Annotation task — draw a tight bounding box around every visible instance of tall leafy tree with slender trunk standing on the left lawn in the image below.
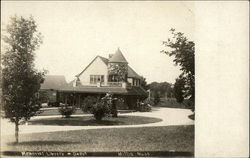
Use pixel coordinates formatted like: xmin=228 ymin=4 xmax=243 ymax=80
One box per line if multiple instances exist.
xmin=2 ymin=16 xmax=44 ymax=143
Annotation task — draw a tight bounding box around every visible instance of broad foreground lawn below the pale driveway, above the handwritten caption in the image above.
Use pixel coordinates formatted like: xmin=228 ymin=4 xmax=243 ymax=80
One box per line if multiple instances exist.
xmin=2 ymin=125 xmax=194 ymax=152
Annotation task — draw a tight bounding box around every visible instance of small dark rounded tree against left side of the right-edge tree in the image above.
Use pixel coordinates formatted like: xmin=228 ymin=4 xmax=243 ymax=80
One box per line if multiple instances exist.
xmin=174 ymin=77 xmax=185 ymax=103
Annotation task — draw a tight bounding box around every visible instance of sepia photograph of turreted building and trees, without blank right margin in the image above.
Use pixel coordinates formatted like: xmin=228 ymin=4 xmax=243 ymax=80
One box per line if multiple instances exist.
xmin=0 ymin=1 xmax=248 ymax=157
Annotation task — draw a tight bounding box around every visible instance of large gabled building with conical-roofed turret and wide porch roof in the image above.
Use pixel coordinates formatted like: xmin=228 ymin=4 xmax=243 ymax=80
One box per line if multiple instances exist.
xmin=40 ymin=48 xmax=147 ymax=109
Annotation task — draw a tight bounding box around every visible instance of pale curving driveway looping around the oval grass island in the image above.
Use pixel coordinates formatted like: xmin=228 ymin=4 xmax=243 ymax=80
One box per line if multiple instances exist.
xmin=1 ymin=107 xmax=194 ymax=136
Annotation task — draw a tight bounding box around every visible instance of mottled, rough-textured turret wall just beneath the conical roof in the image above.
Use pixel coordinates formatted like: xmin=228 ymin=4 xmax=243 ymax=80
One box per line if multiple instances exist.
xmin=108 ymin=63 xmax=128 ymax=82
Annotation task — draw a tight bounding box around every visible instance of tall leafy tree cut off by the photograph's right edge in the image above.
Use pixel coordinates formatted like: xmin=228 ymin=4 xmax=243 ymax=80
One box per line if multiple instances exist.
xmin=161 ymin=29 xmax=195 ymax=110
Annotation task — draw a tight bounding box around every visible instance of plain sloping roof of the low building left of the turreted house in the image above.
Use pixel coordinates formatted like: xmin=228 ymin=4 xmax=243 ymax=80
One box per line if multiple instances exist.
xmin=40 ymin=75 xmax=68 ymax=90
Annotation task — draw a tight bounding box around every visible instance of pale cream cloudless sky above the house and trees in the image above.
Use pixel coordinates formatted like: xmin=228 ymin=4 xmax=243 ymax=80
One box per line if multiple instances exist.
xmin=1 ymin=1 xmax=194 ymax=83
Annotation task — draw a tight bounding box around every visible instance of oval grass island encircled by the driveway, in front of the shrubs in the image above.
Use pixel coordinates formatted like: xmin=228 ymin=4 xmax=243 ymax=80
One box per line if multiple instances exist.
xmin=29 ymin=116 xmax=162 ymax=126
